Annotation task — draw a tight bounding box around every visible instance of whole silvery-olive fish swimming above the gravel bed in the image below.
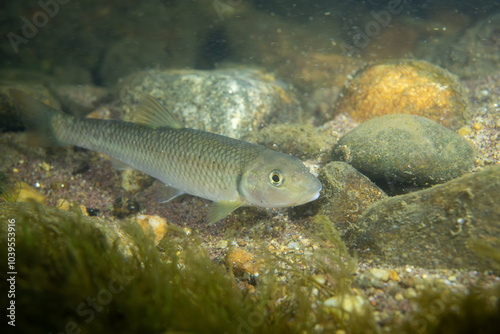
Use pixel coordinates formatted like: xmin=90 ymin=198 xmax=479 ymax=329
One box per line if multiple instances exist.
xmin=9 ymin=89 xmax=322 ymax=225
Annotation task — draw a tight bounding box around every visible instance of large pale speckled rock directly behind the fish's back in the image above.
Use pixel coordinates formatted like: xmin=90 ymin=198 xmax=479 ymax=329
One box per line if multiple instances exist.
xmin=118 ymin=69 xmax=301 ymax=138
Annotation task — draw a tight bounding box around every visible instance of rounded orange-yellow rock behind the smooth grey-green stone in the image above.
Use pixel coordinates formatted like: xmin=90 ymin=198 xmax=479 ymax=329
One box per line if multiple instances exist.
xmin=335 ymin=60 xmax=470 ymax=129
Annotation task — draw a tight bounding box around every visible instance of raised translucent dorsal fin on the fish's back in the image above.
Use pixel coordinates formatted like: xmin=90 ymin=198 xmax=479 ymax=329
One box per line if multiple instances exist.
xmin=133 ymin=95 xmax=182 ymax=129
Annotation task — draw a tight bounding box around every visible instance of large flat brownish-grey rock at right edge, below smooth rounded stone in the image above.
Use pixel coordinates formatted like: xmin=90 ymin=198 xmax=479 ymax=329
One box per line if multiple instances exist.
xmin=344 ymin=166 xmax=500 ymax=270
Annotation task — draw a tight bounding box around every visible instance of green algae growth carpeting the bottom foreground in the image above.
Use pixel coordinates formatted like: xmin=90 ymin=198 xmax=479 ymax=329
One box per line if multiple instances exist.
xmin=0 ymin=203 xmax=500 ymax=333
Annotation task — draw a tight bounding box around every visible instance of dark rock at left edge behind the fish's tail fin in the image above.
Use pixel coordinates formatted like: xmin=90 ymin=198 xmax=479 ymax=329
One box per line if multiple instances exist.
xmin=0 ymin=81 xmax=61 ymax=132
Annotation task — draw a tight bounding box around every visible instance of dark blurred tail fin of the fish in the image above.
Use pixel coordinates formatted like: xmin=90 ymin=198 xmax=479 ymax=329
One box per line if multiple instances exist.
xmin=9 ymin=89 xmax=61 ymax=146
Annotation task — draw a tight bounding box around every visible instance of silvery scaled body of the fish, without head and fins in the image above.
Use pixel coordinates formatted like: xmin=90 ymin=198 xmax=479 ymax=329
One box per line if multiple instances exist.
xmin=52 ymin=116 xmax=265 ymax=200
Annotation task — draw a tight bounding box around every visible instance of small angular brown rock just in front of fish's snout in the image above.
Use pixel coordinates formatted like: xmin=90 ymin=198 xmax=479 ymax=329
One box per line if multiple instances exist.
xmin=311 ymin=161 xmax=387 ymax=235
